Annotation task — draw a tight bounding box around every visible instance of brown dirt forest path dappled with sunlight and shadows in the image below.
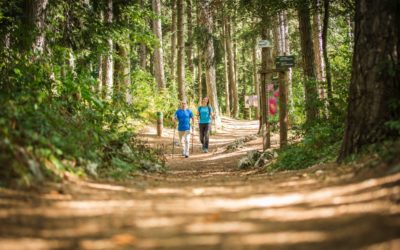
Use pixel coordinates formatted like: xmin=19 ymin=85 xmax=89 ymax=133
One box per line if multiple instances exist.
xmin=0 ymin=119 xmax=400 ymax=250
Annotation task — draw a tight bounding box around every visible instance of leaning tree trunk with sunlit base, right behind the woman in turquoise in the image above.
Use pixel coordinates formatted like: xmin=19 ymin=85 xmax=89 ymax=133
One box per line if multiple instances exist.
xmin=198 ymin=1 xmax=221 ymax=127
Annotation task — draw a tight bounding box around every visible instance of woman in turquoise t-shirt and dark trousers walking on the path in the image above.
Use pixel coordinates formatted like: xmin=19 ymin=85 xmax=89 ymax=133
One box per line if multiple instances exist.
xmin=197 ymin=97 xmax=214 ymax=153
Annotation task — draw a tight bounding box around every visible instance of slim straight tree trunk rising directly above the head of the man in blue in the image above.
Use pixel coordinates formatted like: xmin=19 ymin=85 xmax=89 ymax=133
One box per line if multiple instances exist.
xmin=176 ymin=0 xmax=186 ymax=100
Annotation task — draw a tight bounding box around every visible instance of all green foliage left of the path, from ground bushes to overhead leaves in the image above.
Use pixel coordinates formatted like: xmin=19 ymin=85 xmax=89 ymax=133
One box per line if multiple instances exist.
xmin=0 ymin=1 xmax=168 ymax=185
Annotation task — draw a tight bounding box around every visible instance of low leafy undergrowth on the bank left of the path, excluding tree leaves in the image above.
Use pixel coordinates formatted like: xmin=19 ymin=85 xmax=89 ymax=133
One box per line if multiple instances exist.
xmin=0 ymin=51 xmax=170 ymax=185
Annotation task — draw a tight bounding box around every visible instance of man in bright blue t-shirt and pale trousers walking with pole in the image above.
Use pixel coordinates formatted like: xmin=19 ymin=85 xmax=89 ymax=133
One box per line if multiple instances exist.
xmin=174 ymin=101 xmax=194 ymax=158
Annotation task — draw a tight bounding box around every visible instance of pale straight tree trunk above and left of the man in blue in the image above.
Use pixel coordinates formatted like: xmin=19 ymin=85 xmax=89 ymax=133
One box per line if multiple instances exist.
xmin=152 ymin=0 xmax=165 ymax=90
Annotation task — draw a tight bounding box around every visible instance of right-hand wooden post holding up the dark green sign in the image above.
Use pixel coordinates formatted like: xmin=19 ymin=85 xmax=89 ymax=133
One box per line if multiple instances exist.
xmin=279 ymin=70 xmax=288 ymax=148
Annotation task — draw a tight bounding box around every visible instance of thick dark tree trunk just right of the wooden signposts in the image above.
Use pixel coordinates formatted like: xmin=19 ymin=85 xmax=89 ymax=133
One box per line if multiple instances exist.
xmin=298 ymin=1 xmax=318 ymax=124
